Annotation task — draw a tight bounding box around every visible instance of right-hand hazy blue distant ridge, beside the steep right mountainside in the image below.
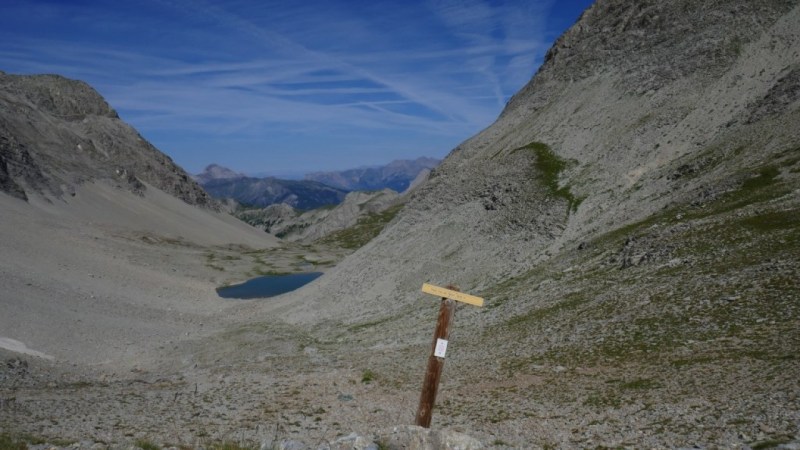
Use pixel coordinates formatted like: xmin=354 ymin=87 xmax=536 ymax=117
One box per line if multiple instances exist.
xmin=305 ymin=157 xmax=441 ymax=192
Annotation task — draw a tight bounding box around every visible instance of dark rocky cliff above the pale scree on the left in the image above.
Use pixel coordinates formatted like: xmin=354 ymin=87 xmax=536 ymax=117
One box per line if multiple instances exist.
xmin=0 ymin=73 xmax=218 ymax=209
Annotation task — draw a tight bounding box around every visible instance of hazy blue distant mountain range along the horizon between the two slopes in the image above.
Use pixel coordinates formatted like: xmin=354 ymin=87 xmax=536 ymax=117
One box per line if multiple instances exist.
xmin=194 ymin=157 xmax=439 ymax=210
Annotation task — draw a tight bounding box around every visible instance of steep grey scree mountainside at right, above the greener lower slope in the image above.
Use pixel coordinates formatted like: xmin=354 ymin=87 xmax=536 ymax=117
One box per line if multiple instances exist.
xmin=290 ymin=1 xmax=800 ymax=320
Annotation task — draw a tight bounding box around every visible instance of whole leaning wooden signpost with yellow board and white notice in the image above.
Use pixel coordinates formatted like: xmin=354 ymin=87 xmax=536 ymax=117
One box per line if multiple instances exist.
xmin=416 ymin=283 xmax=483 ymax=428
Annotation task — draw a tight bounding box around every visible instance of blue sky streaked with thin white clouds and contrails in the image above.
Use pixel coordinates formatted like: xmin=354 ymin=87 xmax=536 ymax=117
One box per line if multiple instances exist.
xmin=0 ymin=0 xmax=592 ymax=176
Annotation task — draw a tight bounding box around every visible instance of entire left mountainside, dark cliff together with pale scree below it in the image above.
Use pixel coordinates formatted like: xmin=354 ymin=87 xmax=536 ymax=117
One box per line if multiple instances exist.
xmin=0 ymin=68 xmax=278 ymax=384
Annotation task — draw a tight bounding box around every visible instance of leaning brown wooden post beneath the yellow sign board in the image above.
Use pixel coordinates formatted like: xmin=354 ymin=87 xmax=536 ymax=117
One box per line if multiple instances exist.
xmin=416 ymin=298 xmax=456 ymax=428
